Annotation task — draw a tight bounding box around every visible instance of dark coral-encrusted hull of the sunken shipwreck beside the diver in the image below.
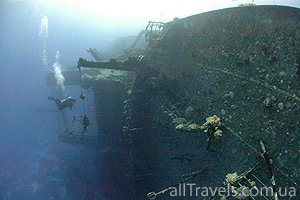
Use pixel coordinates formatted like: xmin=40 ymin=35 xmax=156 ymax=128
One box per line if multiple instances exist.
xmin=48 ymin=6 xmax=300 ymax=199
